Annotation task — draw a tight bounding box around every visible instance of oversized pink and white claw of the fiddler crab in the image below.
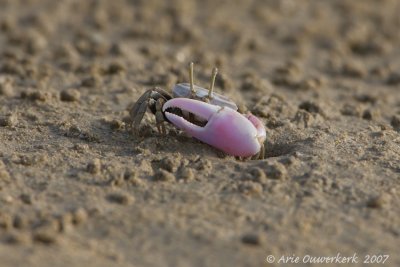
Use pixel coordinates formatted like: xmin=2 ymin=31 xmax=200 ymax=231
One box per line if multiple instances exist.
xmin=163 ymin=98 xmax=266 ymax=157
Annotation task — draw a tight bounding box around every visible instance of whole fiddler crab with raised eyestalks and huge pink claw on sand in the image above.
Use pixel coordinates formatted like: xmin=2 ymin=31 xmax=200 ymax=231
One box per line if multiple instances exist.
xmin=129 ymin=63 xmax=266 ymax=159
